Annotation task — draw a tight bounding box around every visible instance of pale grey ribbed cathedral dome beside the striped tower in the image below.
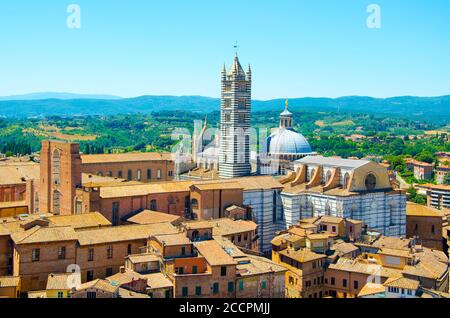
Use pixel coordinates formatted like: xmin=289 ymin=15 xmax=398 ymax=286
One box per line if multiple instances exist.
xmin=267 ymin=128 xmax=313 ymax=154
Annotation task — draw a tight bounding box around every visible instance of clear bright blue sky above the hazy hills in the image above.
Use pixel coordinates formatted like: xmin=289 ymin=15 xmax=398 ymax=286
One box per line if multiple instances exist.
xmin=0 ymin=0 xmax=450 ymax=99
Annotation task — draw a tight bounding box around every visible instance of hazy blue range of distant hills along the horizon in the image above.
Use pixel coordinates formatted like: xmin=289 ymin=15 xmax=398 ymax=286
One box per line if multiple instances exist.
xmin=0 ymin=94 xmax=450 ymax=123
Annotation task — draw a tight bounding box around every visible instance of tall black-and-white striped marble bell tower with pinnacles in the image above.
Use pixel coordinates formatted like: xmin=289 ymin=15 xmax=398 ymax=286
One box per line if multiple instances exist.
xmin=219 ymin=54 xmax=252 ymax=178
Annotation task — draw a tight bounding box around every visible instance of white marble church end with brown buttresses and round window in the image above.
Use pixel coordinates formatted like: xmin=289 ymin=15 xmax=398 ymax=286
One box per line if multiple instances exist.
xmin=281 ymin=156 xmax=406 ymax=236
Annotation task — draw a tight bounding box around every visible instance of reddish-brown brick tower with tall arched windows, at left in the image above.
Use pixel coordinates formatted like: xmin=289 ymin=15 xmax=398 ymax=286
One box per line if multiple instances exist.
xmin=39 ymin=140 xmax=81 ymax=215
